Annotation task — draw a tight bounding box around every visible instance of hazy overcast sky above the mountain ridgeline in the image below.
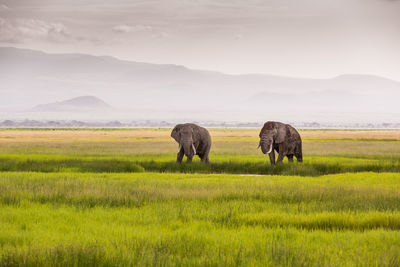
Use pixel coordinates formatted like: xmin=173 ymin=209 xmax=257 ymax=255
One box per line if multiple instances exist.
xmin=0 ymin=0 xmax=400 ymax=81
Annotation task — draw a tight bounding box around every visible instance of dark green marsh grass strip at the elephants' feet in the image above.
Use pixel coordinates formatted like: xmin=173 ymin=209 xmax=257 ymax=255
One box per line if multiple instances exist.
xmin=0 ymin=154 xmax=400 ymax=176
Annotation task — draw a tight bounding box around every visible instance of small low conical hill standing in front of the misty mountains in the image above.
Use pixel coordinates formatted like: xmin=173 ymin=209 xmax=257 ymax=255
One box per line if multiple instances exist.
xmin=32 ymin=96 xmax=112 ymax=112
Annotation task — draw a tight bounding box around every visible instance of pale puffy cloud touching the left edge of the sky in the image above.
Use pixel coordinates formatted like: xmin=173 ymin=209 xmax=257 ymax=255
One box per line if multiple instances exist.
xmin=0 ymin=18 xmax=71 ymax=43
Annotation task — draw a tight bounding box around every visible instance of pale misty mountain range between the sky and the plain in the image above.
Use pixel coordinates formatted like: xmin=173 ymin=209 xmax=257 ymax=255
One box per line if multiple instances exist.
xmin=0 ymin=47 xmax=400 ymax=124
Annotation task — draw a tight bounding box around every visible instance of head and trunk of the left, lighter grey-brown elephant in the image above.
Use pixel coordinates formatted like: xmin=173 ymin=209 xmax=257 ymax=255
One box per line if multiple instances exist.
xmin=171 ymin=124 xmax=197 ymax=159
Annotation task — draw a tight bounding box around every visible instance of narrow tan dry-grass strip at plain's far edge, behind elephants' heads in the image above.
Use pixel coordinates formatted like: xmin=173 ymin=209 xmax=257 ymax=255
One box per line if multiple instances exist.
xmin=0 ymin=129 xmax=400 ymax=143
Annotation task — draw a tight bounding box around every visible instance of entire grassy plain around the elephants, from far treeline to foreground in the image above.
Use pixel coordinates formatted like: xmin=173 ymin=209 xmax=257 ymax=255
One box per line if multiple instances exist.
xmin=0 ymin=129 xmax=400 ymax=266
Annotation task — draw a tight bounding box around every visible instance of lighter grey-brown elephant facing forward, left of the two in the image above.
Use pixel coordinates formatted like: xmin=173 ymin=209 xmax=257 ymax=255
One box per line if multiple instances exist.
xmin=171 ymin=123 xmax=211 ymax=163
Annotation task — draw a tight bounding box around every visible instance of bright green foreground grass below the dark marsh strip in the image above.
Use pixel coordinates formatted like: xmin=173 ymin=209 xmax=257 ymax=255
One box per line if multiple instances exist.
xmin=0 ymin=173 xmax=400 ymax=266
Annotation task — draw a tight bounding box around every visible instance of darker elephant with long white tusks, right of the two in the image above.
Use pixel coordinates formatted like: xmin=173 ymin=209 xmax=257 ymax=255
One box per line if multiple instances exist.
xmin=257 ymin=121 xmax=303 ymax=164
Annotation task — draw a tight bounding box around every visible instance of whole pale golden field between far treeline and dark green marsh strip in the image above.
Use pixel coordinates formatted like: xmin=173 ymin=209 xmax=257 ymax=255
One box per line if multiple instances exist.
xmin=0 ymin=129 xmax=400 ymax=155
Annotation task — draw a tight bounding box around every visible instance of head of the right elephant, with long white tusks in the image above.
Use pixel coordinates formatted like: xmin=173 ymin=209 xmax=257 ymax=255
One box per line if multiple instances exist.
xmin=257 ymin=121 xmax=290 ymax=154
